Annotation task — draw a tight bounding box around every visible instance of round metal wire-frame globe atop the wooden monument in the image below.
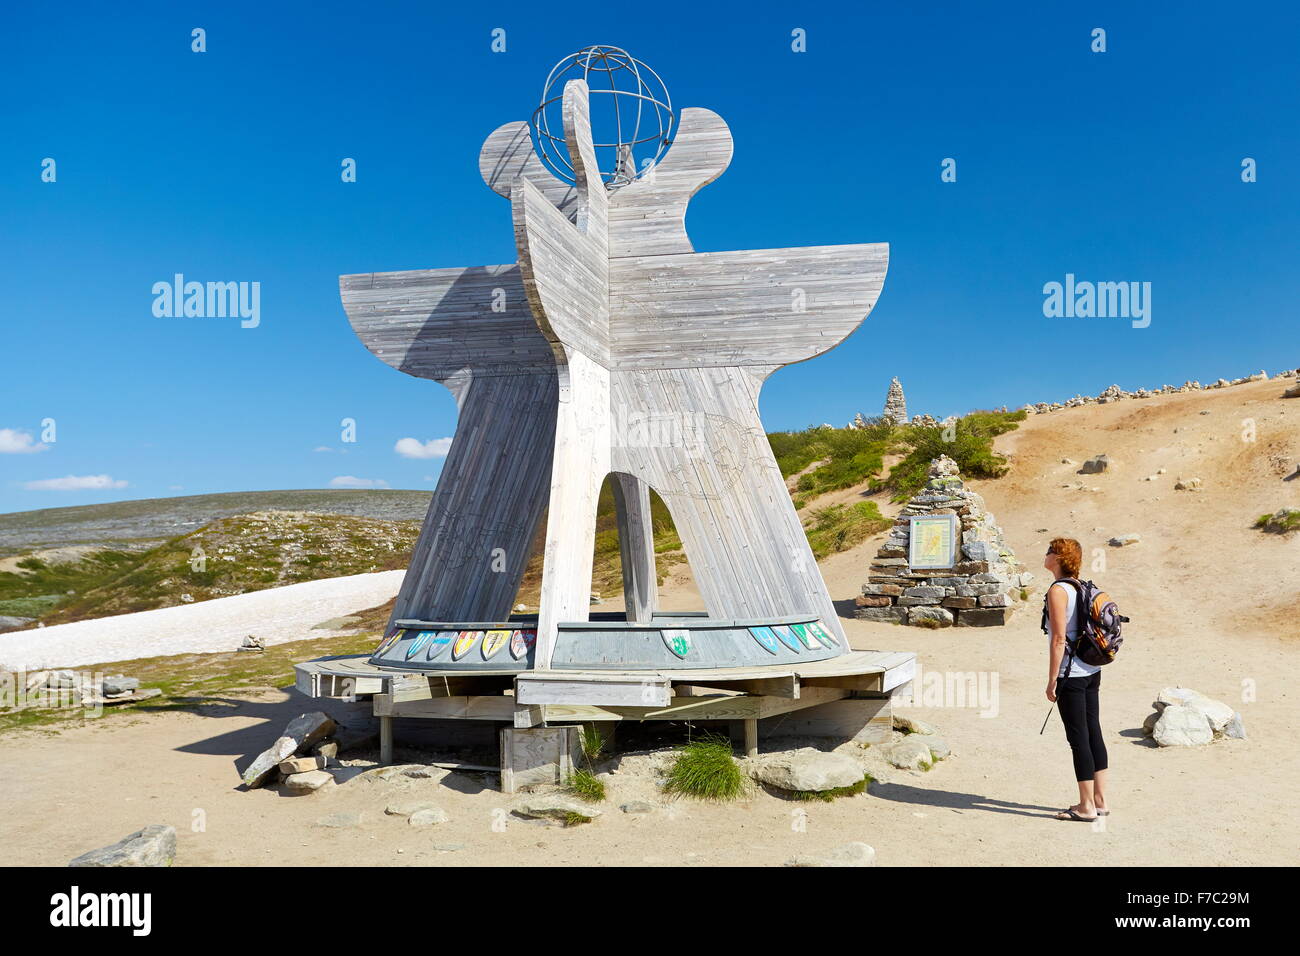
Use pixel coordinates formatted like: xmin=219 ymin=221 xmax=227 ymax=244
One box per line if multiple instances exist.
xmin=529 ymin=44 xmax=677 ymax=190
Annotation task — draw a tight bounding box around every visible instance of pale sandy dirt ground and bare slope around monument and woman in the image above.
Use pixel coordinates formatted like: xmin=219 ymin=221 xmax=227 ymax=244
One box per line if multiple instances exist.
xmin=0 ymin=382 xmax=1300 ymax=866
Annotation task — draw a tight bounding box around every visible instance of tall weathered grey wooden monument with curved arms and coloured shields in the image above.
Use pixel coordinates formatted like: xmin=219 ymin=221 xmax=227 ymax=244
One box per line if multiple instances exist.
xmin=301 ymin=47 xmax=910 ymax=759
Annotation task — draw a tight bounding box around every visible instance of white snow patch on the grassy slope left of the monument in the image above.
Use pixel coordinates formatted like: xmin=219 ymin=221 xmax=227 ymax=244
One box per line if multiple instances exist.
xmin=0 ymin=571 xmax=406 ymax=670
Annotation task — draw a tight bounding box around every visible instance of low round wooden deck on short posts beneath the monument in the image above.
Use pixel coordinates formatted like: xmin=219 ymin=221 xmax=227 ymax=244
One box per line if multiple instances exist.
xmin=295 ymin=650 xmax=917 ymax=762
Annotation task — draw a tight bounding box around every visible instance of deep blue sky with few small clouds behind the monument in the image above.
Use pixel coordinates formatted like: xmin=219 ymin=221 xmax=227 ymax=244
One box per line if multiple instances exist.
xmin=0 ymin=3 xmax=1300 ymax=511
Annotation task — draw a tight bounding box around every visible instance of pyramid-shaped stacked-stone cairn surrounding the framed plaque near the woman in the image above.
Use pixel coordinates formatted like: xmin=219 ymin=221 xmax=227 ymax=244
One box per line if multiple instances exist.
xmin=855 ymin=455 xmax=1034 ymax=627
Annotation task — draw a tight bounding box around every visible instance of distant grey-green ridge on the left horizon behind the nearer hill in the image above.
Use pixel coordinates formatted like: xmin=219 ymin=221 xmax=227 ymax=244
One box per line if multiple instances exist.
xmin=0 ymin=489 xmax=433 ymax=558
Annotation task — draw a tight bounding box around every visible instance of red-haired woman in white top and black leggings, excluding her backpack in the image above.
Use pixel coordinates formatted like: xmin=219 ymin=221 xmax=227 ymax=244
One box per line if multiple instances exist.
xmin=1043 ymin=537 xmax=1110 ymax=822
